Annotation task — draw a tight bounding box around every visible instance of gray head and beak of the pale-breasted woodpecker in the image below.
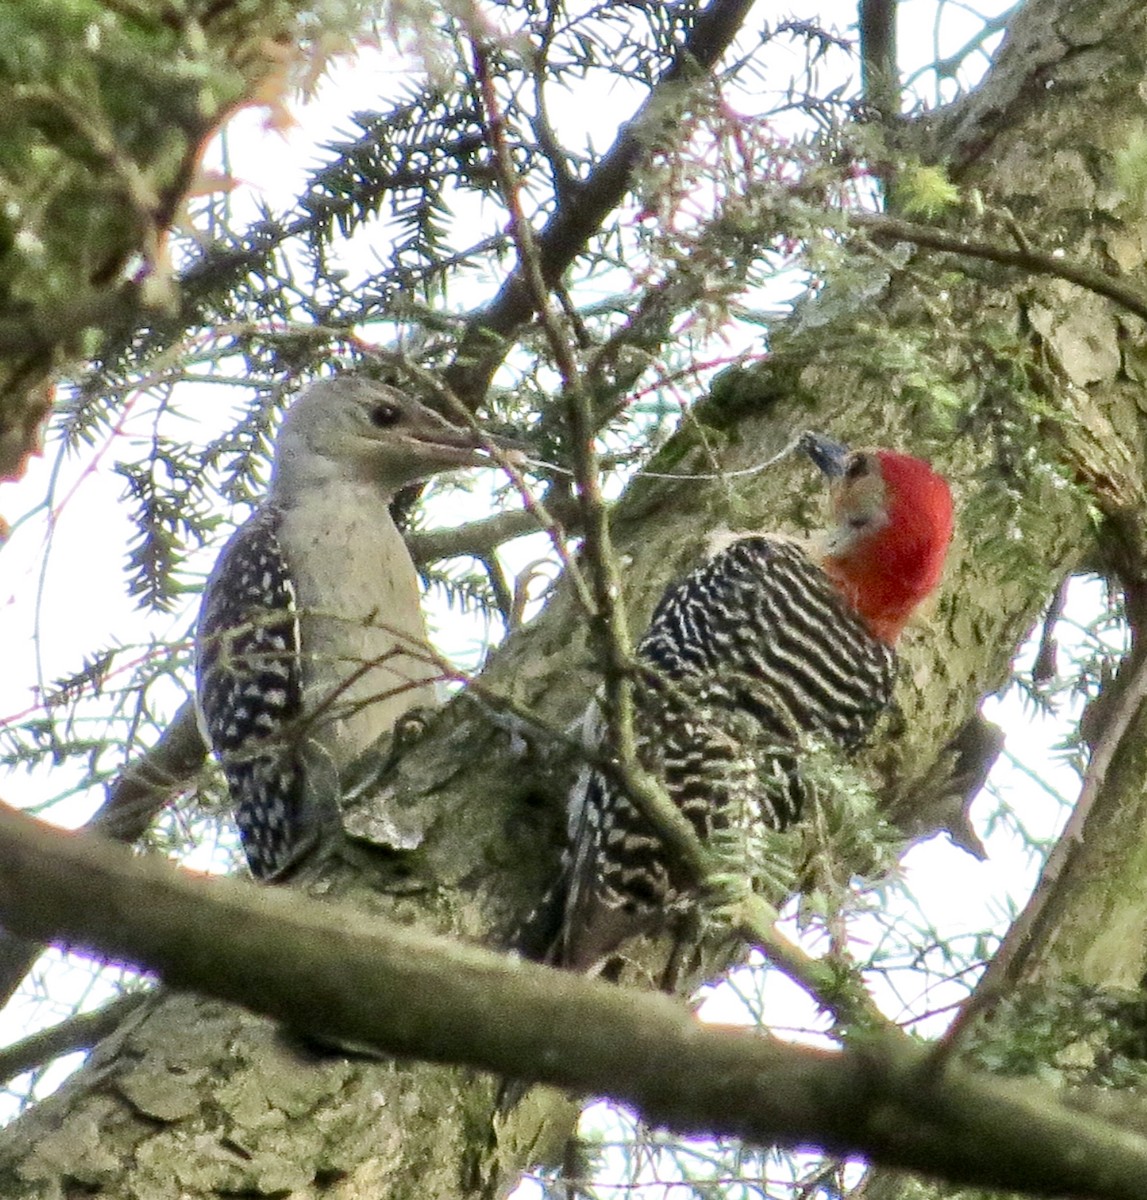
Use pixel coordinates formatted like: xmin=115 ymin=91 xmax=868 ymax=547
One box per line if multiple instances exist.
xmin=271 ymin=376 xmax=520 ymax=496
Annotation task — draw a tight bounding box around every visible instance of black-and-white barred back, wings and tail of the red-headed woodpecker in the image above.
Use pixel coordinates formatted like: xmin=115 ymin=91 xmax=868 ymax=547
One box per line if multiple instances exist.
xmin=553 ymin=536 xmax=896 ymax=970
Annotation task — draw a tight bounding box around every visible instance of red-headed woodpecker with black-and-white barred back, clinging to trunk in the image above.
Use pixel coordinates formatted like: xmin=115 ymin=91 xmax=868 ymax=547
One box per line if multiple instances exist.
xmin=550 ymin=434 xmax=953 ymax=971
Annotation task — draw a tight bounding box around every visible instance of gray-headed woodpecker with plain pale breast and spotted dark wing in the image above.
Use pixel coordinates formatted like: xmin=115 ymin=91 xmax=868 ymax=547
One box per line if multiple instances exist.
xmin=196 ymin=376 xmax=515 ymax=881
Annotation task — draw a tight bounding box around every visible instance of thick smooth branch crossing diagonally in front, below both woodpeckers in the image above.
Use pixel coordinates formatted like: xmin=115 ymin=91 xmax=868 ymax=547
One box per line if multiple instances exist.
xmin=0 ymin=809 xmax=1147 ymax=1200
